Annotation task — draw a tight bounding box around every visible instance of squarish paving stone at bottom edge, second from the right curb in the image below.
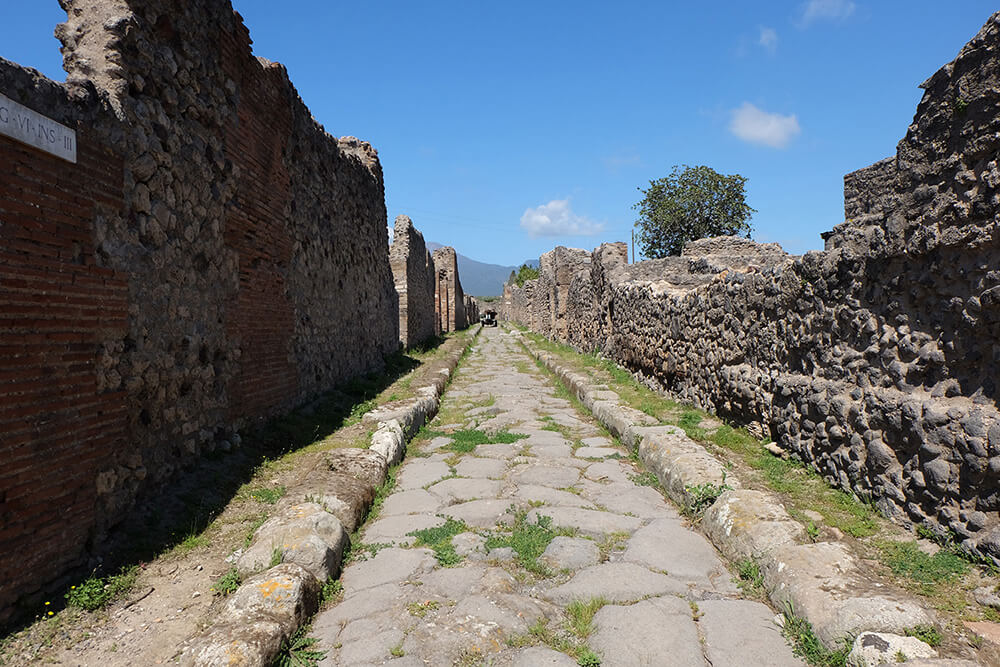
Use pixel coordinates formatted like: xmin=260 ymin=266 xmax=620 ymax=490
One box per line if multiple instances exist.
xmin=590 ymin=597 xmax=706 ymax=667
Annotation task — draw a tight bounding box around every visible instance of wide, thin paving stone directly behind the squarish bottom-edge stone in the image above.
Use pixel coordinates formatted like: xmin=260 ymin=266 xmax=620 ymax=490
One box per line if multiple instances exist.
xmin=543 ymin=563 xmax=690 ymax=614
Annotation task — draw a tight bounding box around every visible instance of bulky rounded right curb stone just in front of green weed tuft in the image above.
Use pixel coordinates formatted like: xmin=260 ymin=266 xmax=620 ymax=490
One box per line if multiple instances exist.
xmin=701 ymin=489 xmax=806 ymax=562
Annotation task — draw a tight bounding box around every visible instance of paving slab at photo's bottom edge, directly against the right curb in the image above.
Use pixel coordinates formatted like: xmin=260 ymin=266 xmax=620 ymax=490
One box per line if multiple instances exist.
xmin=698 ymin=600 xmax=805 ymax=667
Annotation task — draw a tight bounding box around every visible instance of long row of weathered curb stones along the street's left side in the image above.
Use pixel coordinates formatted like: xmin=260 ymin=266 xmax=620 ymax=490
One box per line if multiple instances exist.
xmin=180 ymin=325 xmax=482 ymax=667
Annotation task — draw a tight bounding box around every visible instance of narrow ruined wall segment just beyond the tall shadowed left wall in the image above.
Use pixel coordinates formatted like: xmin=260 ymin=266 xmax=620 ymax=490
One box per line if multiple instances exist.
xmin=389 ymin=215 xmax=441 ymax=348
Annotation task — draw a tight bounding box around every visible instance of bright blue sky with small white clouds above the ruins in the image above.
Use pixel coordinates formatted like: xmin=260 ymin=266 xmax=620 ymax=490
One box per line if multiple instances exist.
xmin=0 ymin=0 xmax=995 ymax=264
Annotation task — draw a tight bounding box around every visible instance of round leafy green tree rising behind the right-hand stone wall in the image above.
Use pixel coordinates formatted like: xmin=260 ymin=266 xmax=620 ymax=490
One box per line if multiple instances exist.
xmin=632 ymin=165 xmax=756 ymax=259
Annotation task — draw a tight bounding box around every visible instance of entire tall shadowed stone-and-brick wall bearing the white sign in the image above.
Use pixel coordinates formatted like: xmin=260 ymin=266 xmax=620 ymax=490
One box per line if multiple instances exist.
xmin=0 ymin=0 xmax=398 ymax=618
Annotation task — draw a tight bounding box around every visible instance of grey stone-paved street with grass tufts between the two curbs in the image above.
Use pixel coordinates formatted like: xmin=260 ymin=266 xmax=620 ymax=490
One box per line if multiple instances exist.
xmin=312 ymin=329 xmax=801 ymax=667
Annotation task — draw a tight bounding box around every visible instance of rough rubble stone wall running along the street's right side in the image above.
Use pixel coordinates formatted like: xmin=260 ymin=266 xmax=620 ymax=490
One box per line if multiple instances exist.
xmin=504 ymin=14 xmax=1000 ymax=562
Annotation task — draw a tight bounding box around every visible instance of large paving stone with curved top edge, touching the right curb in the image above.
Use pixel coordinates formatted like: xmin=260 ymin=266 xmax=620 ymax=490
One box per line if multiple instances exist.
xmin=622 ymin=519 xmax=739 ymax=594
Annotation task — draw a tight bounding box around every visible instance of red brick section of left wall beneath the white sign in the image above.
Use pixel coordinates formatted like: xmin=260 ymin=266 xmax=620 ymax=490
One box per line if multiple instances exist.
xmin=0 ymin=63 xmax=128 ymax=620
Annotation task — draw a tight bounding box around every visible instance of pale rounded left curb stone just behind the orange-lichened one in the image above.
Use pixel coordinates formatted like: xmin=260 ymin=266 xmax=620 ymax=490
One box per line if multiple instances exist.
xmin=236 ymin=503 xmax=349 ymax=582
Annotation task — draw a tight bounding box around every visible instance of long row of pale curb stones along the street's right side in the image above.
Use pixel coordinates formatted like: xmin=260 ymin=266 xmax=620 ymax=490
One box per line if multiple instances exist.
xmin=513 ymin=332 xmax=944 ymax=664
